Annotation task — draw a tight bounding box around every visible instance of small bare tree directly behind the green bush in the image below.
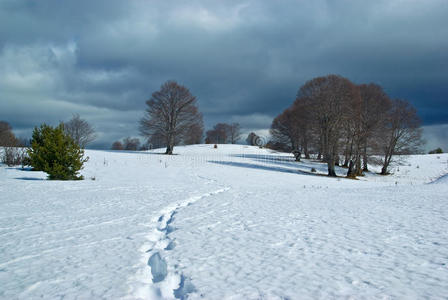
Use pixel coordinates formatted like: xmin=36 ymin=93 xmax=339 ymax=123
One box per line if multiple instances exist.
xmin=63 ymin=114 xmax=96 ymax=148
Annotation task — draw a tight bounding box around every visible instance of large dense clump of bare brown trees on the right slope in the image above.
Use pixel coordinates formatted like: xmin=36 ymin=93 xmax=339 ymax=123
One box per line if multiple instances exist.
xmin=270 ymin=75 xmax=421 ymax=177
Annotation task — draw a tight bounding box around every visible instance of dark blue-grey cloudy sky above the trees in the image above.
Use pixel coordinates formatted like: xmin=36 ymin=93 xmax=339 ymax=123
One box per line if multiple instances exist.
xmin=0 ymin=0 xmax=448 ymax=150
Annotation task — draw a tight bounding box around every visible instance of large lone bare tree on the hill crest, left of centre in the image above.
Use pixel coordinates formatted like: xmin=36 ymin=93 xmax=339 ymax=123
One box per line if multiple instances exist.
xmin=140 ymin=81 xmax=202 ymax=154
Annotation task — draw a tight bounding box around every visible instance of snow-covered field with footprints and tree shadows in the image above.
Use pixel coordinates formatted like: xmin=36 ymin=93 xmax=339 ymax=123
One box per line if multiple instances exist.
xmin=0 ymin=145 xmax=448 ymax=299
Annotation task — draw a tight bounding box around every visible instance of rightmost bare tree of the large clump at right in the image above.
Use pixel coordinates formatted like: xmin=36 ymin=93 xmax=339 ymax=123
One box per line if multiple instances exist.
xmin=381 ymin=99 xmax=422 ymax=175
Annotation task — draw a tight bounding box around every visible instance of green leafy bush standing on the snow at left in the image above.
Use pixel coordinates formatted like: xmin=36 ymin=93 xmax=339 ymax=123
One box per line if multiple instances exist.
xmin=28 ymin=124 xmax=88 ymax=180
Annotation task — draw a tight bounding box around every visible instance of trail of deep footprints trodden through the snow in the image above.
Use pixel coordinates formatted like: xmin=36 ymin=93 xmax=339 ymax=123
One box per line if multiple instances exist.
xmin=127 ymin=186 xmax=230 ymax=299
